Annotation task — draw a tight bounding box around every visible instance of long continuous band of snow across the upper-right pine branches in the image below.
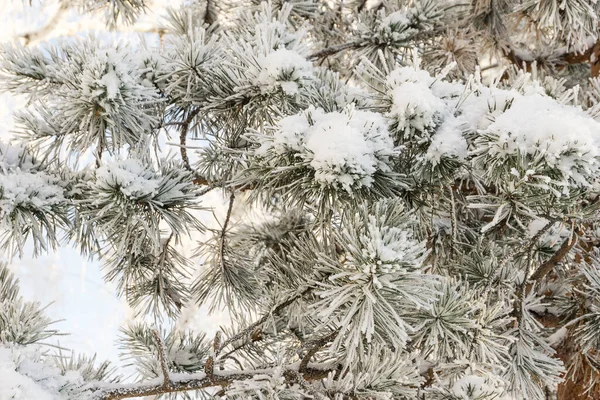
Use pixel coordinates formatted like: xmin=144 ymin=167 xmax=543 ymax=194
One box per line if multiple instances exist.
xmin=386 ymin=67 xmax=600 ymax=186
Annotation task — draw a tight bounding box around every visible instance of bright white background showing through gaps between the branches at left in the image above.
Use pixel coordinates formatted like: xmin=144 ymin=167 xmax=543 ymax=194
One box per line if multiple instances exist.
xmin=0 ymin=0 xmax=232 ymax=378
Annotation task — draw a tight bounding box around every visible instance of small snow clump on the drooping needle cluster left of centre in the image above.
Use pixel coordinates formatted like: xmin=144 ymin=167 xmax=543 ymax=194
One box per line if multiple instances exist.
xmin=96 ymin=159 xmax=160 ymax=199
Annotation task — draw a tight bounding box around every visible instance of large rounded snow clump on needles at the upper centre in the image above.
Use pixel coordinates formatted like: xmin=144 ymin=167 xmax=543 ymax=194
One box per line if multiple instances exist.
xmin=256 ymin=106 xmax=395 ymax=192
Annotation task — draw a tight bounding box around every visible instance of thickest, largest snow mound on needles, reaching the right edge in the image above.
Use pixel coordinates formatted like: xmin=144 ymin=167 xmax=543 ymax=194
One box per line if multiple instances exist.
xmin=461 ymin=89 xmax=600 ymax=192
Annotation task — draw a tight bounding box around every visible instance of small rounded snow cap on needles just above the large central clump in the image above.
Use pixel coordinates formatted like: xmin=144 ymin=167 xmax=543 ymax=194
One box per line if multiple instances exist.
xmin=256 ymin=48 xmax=313 ymax=96
